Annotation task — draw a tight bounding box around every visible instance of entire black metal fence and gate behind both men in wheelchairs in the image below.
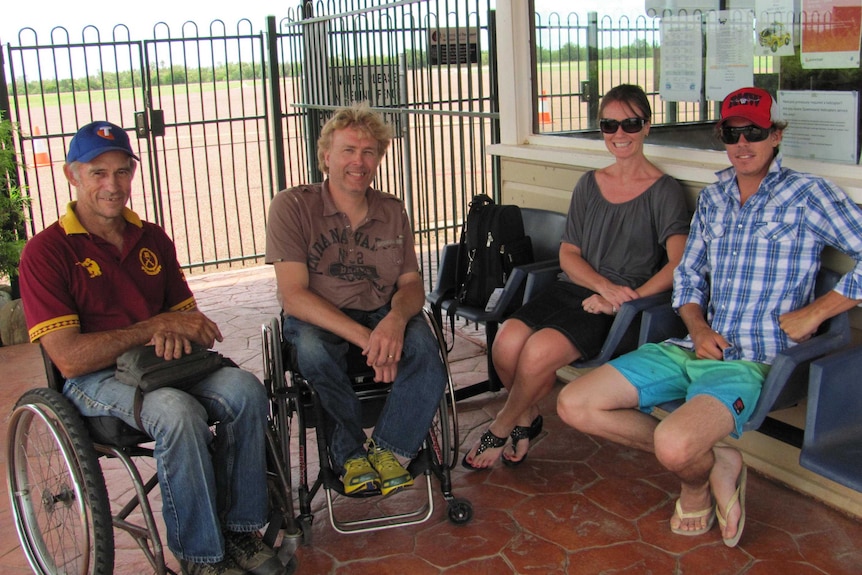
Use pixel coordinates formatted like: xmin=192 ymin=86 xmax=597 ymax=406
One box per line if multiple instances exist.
xmin=0 ymin=0 xmax=499 ymax=283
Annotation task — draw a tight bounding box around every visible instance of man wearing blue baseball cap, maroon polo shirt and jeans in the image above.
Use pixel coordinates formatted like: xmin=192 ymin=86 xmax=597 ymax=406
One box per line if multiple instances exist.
xmin=20 ymin=122 xmax=285 ymax=575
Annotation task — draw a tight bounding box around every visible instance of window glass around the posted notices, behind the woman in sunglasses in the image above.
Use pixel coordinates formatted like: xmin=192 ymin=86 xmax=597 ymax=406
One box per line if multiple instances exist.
xmin=532 ymin=0 xmax=862 ymax=163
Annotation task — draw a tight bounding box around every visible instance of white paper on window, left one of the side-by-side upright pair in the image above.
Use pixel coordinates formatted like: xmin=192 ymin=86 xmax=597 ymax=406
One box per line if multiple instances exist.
xmin=659 ymin=15 xmax=703 ymax=102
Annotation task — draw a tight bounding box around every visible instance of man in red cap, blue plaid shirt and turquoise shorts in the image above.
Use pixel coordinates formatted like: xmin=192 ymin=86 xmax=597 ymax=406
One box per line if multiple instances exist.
xmin=557 ymin=88 xmax=862 ymax=547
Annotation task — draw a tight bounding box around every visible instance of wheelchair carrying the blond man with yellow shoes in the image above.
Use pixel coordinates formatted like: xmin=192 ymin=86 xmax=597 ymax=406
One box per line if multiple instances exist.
xmin=261 ymin=310 xmax=473 ymax=545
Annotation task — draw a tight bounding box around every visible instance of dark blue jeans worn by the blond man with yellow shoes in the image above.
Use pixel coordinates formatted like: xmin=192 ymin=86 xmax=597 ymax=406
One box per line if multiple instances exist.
xmin=284 ymin=306 xmax=447 ymax=469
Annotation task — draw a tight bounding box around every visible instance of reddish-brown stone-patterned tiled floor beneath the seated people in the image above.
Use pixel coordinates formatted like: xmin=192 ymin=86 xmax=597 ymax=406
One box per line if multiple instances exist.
xmin=0 ymin=268 xmax=862 ymax=575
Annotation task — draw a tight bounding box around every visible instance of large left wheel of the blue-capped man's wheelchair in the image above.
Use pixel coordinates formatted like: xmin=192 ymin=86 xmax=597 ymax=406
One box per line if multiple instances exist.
xmin=6 ymin=388 xmax=114 ymax=575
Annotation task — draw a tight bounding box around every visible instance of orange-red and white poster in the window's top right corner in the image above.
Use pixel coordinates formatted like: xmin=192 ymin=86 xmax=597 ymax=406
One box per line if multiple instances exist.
xmin=800 ymin=0 xmax=862 ymax=69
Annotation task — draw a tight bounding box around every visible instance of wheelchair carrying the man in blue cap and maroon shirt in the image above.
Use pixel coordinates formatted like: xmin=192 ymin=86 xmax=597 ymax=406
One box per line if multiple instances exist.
xmin=6 ymin=349 xmax=299 ymax=575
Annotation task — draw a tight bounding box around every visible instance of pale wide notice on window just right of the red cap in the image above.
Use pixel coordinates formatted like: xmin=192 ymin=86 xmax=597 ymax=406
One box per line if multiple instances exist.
xmin=778 ymin=90 xmax=859 ymax=164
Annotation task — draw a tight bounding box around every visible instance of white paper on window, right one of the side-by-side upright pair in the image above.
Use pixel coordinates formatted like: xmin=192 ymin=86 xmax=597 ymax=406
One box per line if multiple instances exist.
xmin=706 ymin=10 xmax=754 ymax=101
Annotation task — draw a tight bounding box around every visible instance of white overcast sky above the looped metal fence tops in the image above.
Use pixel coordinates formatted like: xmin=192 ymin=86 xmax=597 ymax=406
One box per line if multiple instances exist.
xmin=0 ymin=0 xmax=644 ymax=45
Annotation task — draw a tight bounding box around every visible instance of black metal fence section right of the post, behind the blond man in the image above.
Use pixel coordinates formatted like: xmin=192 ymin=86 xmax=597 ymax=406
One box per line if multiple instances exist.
xmin=277 ymin=0 xmax=499 ymax=286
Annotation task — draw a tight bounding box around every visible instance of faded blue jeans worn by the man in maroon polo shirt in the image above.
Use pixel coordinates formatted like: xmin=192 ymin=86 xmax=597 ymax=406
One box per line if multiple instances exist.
xmin=63 ymin=367 xmax=268 ymax=563
